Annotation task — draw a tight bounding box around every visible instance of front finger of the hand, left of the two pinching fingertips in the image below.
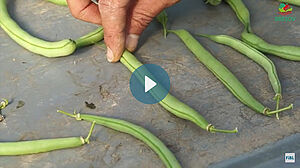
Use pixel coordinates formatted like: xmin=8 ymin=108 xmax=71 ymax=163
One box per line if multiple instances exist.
xmin=99 ymin=0 xmax=129 ymax=62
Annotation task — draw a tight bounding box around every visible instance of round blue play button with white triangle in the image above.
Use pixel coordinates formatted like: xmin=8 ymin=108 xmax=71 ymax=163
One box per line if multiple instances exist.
xmin=130 ymin=64 xmax=170 ymax=104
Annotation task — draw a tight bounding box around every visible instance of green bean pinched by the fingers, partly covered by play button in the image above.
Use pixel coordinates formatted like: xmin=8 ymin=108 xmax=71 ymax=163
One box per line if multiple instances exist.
xmin=120 ymin=51 xmax=237 ymax=133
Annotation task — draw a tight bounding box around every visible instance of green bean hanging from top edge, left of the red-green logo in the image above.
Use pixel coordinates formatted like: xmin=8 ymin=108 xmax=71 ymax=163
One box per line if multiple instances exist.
xmin=225 ymin=0 xmax=252 ymax=32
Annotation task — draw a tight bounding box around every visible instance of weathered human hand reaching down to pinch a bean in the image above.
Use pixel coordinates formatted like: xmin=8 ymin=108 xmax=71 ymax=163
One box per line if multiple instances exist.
xmin=67 ymin=0 xmax=179 ymax=62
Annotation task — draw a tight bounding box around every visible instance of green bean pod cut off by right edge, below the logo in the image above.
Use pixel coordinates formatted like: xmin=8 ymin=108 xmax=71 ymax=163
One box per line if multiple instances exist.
xmin=242 ymin=31 xmax=300 ymax=61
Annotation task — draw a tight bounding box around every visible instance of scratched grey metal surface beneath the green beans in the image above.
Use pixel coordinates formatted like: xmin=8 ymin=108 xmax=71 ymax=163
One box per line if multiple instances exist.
xmin=0 ymin=0 xmax=300 ymax=168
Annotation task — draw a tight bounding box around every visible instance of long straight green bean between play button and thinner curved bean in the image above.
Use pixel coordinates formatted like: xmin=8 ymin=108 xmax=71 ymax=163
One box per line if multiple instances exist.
xmin=169 ymin=30 xmax=293 ymax=115
